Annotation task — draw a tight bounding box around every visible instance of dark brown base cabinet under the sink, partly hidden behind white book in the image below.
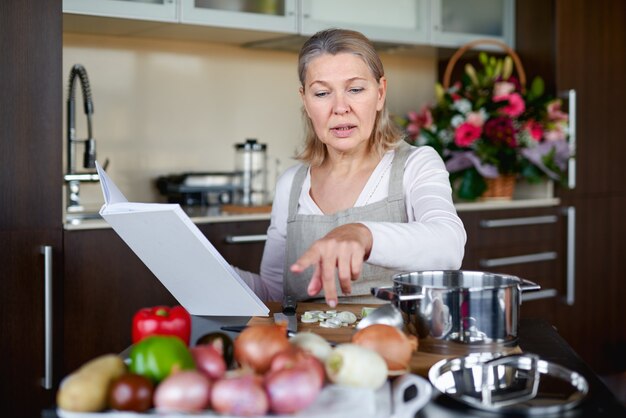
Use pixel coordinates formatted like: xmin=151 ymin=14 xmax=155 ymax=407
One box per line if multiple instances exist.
xmin=63 ymin=220 xmax=269 ymax=374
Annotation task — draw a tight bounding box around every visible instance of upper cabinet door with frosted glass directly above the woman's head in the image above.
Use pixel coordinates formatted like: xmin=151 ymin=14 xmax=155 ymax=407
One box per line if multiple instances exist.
xmin=301 ymin=0 xmax=428 ymax=44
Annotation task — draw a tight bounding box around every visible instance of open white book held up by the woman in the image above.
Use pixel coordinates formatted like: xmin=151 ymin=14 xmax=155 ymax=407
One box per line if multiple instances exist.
xmin=96 ymin=163 xmax=269 ymax=316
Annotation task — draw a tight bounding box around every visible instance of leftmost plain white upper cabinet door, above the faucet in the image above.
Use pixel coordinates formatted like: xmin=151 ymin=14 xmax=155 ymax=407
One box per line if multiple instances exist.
xmin=63 ymin=0 xmax=177 ymax=22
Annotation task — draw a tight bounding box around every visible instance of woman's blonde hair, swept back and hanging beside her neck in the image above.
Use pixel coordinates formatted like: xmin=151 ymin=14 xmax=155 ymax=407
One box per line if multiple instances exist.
xmin=296 ymin=29 xmax=402 ymax=166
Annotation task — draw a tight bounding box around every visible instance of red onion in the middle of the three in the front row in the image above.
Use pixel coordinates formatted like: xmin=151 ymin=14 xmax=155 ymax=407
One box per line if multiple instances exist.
xmin=211 ymin=374 xmax=269 ymax=416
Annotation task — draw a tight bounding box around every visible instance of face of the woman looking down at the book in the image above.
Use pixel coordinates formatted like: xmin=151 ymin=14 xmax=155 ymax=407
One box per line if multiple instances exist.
xmin=300 ymin=53 xmax=387 ymax=157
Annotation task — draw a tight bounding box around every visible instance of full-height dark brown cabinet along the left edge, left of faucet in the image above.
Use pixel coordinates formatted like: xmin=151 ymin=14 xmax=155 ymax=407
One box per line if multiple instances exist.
xmin=0 ymin=0 xmax=63 ymax=418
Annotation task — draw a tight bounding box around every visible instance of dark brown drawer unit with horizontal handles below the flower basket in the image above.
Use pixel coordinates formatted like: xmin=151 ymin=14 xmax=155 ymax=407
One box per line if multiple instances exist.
xmin=459 ymin=207 xmax=571 ymax=322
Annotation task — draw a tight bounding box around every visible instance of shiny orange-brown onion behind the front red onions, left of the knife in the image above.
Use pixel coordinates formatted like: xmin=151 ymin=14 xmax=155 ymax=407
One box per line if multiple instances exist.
xmin=235 ymin=324 xmax=290 ymax=374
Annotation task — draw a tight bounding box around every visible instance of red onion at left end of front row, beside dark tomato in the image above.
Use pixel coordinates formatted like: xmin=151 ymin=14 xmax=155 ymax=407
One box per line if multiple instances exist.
xmin=154 ymin=370 xmax=211 ymax=412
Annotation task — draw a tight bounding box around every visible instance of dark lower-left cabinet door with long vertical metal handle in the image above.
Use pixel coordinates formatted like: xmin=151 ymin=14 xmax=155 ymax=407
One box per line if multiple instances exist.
xmin=0 ymin=230 xmax=62 ymax=417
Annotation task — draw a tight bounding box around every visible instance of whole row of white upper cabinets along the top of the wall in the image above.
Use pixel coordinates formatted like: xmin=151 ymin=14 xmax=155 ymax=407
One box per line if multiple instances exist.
xmin=63 ymin=0 xmax=515 ymax=47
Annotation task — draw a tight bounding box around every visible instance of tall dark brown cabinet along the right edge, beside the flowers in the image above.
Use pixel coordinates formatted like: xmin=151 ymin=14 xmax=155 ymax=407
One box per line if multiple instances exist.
xmin=516 ymin=0 xmax=626 ymax=373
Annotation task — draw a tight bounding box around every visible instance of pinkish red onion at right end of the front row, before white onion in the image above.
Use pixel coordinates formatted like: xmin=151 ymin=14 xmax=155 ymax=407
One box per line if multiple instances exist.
xmin=265 ymin=365 xmax=322 ymax=414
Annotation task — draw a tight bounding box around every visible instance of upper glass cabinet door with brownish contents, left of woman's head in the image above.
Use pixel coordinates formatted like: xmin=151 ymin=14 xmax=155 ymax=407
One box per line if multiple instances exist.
xmin=181 ymin=0 xmax=297 ymax=34
